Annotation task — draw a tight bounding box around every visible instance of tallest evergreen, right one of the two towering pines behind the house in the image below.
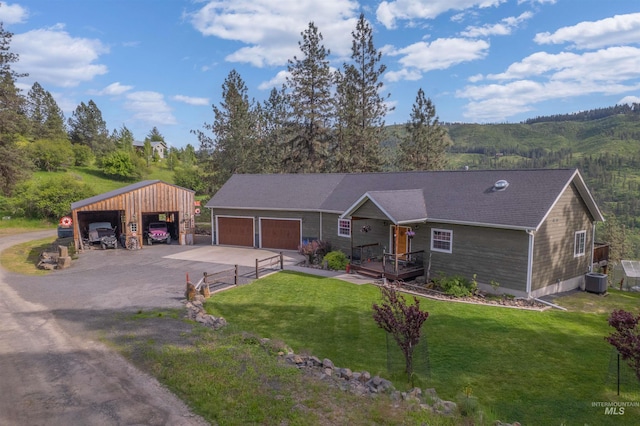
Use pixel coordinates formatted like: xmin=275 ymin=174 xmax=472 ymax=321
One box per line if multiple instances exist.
xmin=334 ymin=14 xmax=388 ymax=172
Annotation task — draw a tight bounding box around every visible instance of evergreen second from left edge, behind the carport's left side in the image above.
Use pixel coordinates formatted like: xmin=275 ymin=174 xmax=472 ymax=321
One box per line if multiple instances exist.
xmin=26 ymin=82 xmax=68 ymax=140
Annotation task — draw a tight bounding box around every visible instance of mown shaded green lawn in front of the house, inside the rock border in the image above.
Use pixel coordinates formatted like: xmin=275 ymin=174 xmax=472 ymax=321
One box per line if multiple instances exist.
xmin=207 ymin=272 xmax=640 ymax=425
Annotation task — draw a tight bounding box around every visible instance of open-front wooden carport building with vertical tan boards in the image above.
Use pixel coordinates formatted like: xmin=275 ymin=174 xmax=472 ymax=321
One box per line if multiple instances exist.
xmin=71 ymin=180 xmax=195 ymax=248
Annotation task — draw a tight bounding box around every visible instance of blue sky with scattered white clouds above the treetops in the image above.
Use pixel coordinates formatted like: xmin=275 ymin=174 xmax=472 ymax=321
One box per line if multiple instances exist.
xmin=0 ymin=0 xmax=640 ymax=148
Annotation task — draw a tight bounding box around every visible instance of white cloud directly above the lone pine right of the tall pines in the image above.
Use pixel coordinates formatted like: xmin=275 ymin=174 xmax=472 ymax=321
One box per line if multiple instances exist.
xmin=387 ymin=38 xmax=489 ymax=81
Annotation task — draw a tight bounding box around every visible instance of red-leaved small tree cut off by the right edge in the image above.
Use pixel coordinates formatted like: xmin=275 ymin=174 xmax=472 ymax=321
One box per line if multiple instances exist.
xmin=605 ymin=309 xmax=640 ymax=380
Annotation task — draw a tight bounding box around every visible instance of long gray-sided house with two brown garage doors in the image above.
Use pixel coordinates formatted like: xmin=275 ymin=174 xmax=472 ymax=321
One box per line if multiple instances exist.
xmin=206 ymin=169 xmax=604 ymax=297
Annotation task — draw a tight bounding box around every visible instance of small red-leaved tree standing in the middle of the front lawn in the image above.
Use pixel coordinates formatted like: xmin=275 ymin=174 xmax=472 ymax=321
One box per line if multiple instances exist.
xmin=373 ymin=285 xmax=429 ymax=379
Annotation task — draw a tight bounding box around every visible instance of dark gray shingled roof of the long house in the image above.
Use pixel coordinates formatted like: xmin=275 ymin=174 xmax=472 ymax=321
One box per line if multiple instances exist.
xmin=206 ymin=169 xmax=604 ymax=229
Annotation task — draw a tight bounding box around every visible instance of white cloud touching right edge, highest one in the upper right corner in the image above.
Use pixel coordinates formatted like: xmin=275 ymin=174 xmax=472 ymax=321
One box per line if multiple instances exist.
xmin=534 ymin=13 xmax=640 ymax=49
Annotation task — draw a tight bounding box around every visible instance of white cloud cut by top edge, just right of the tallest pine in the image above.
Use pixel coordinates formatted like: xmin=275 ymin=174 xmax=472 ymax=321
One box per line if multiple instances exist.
xmin=376 ymin=0 xmax=507 ymax=29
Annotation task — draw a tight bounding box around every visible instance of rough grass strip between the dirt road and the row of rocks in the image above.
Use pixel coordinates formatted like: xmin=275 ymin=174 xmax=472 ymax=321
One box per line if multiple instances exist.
xmin=105 ymin=311 xmax=460 ymax=426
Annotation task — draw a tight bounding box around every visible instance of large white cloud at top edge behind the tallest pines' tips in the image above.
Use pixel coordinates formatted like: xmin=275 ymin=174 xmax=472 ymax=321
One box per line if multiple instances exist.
xmin=186 ymin=0 xmax=359 ymax=67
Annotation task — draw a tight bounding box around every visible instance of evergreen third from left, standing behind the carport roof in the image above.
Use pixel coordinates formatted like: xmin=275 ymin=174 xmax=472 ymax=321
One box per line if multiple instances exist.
xmin=69 ymin=100 xmax=115 ymax=157
